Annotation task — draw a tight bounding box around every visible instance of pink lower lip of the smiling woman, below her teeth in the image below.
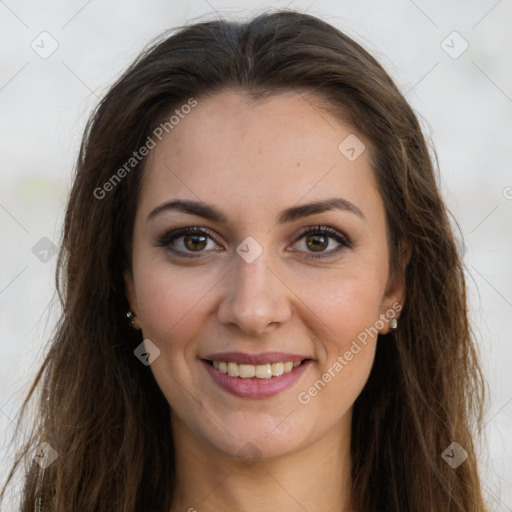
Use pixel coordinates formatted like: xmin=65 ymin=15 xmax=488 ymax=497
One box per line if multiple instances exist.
xmin=201 ymin=359 xmax=313 ymax=398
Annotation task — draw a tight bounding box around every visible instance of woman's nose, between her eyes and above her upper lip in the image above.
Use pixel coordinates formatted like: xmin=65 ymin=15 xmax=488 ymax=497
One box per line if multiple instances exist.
xmin=217 ymin=251 xmax=291 ymax=336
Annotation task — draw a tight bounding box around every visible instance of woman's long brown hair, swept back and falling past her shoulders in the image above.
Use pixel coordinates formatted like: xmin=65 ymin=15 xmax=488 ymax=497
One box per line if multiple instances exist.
xmin=2 ymin=11 xmax=486 ymax=512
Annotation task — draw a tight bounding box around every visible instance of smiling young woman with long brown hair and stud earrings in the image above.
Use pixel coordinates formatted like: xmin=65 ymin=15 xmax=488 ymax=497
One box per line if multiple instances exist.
xmin=0 ymin=11 xmax=486 ymax=512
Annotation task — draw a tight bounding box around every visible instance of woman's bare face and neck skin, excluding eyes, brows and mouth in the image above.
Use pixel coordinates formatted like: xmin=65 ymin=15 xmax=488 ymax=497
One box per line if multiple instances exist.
xmin=125 ymin=90 xmax=406 ymax=512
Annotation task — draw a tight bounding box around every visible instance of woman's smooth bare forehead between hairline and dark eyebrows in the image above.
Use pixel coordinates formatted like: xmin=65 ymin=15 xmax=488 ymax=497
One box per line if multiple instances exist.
xmin=139 ymin=91 xmax=382 ymax=226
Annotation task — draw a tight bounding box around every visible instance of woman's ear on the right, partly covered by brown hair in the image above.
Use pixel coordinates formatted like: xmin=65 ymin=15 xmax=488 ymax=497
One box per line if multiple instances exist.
xmin=379 ymin=242 xmax=412 ymax=334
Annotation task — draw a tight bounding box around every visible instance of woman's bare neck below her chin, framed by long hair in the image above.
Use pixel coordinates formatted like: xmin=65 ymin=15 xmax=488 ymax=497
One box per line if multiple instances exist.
xmin=170 ymin=411 xmax=353 ymax=512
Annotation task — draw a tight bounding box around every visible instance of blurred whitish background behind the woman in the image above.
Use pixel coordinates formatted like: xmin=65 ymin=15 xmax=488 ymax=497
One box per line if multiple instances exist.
xmin=0 ymin=0 xmax=512 ymax=511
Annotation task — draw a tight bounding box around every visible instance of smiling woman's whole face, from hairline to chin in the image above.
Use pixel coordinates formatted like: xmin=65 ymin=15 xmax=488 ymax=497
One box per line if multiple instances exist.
xmin=125 ymin=91 xmax=404 ymax=457
